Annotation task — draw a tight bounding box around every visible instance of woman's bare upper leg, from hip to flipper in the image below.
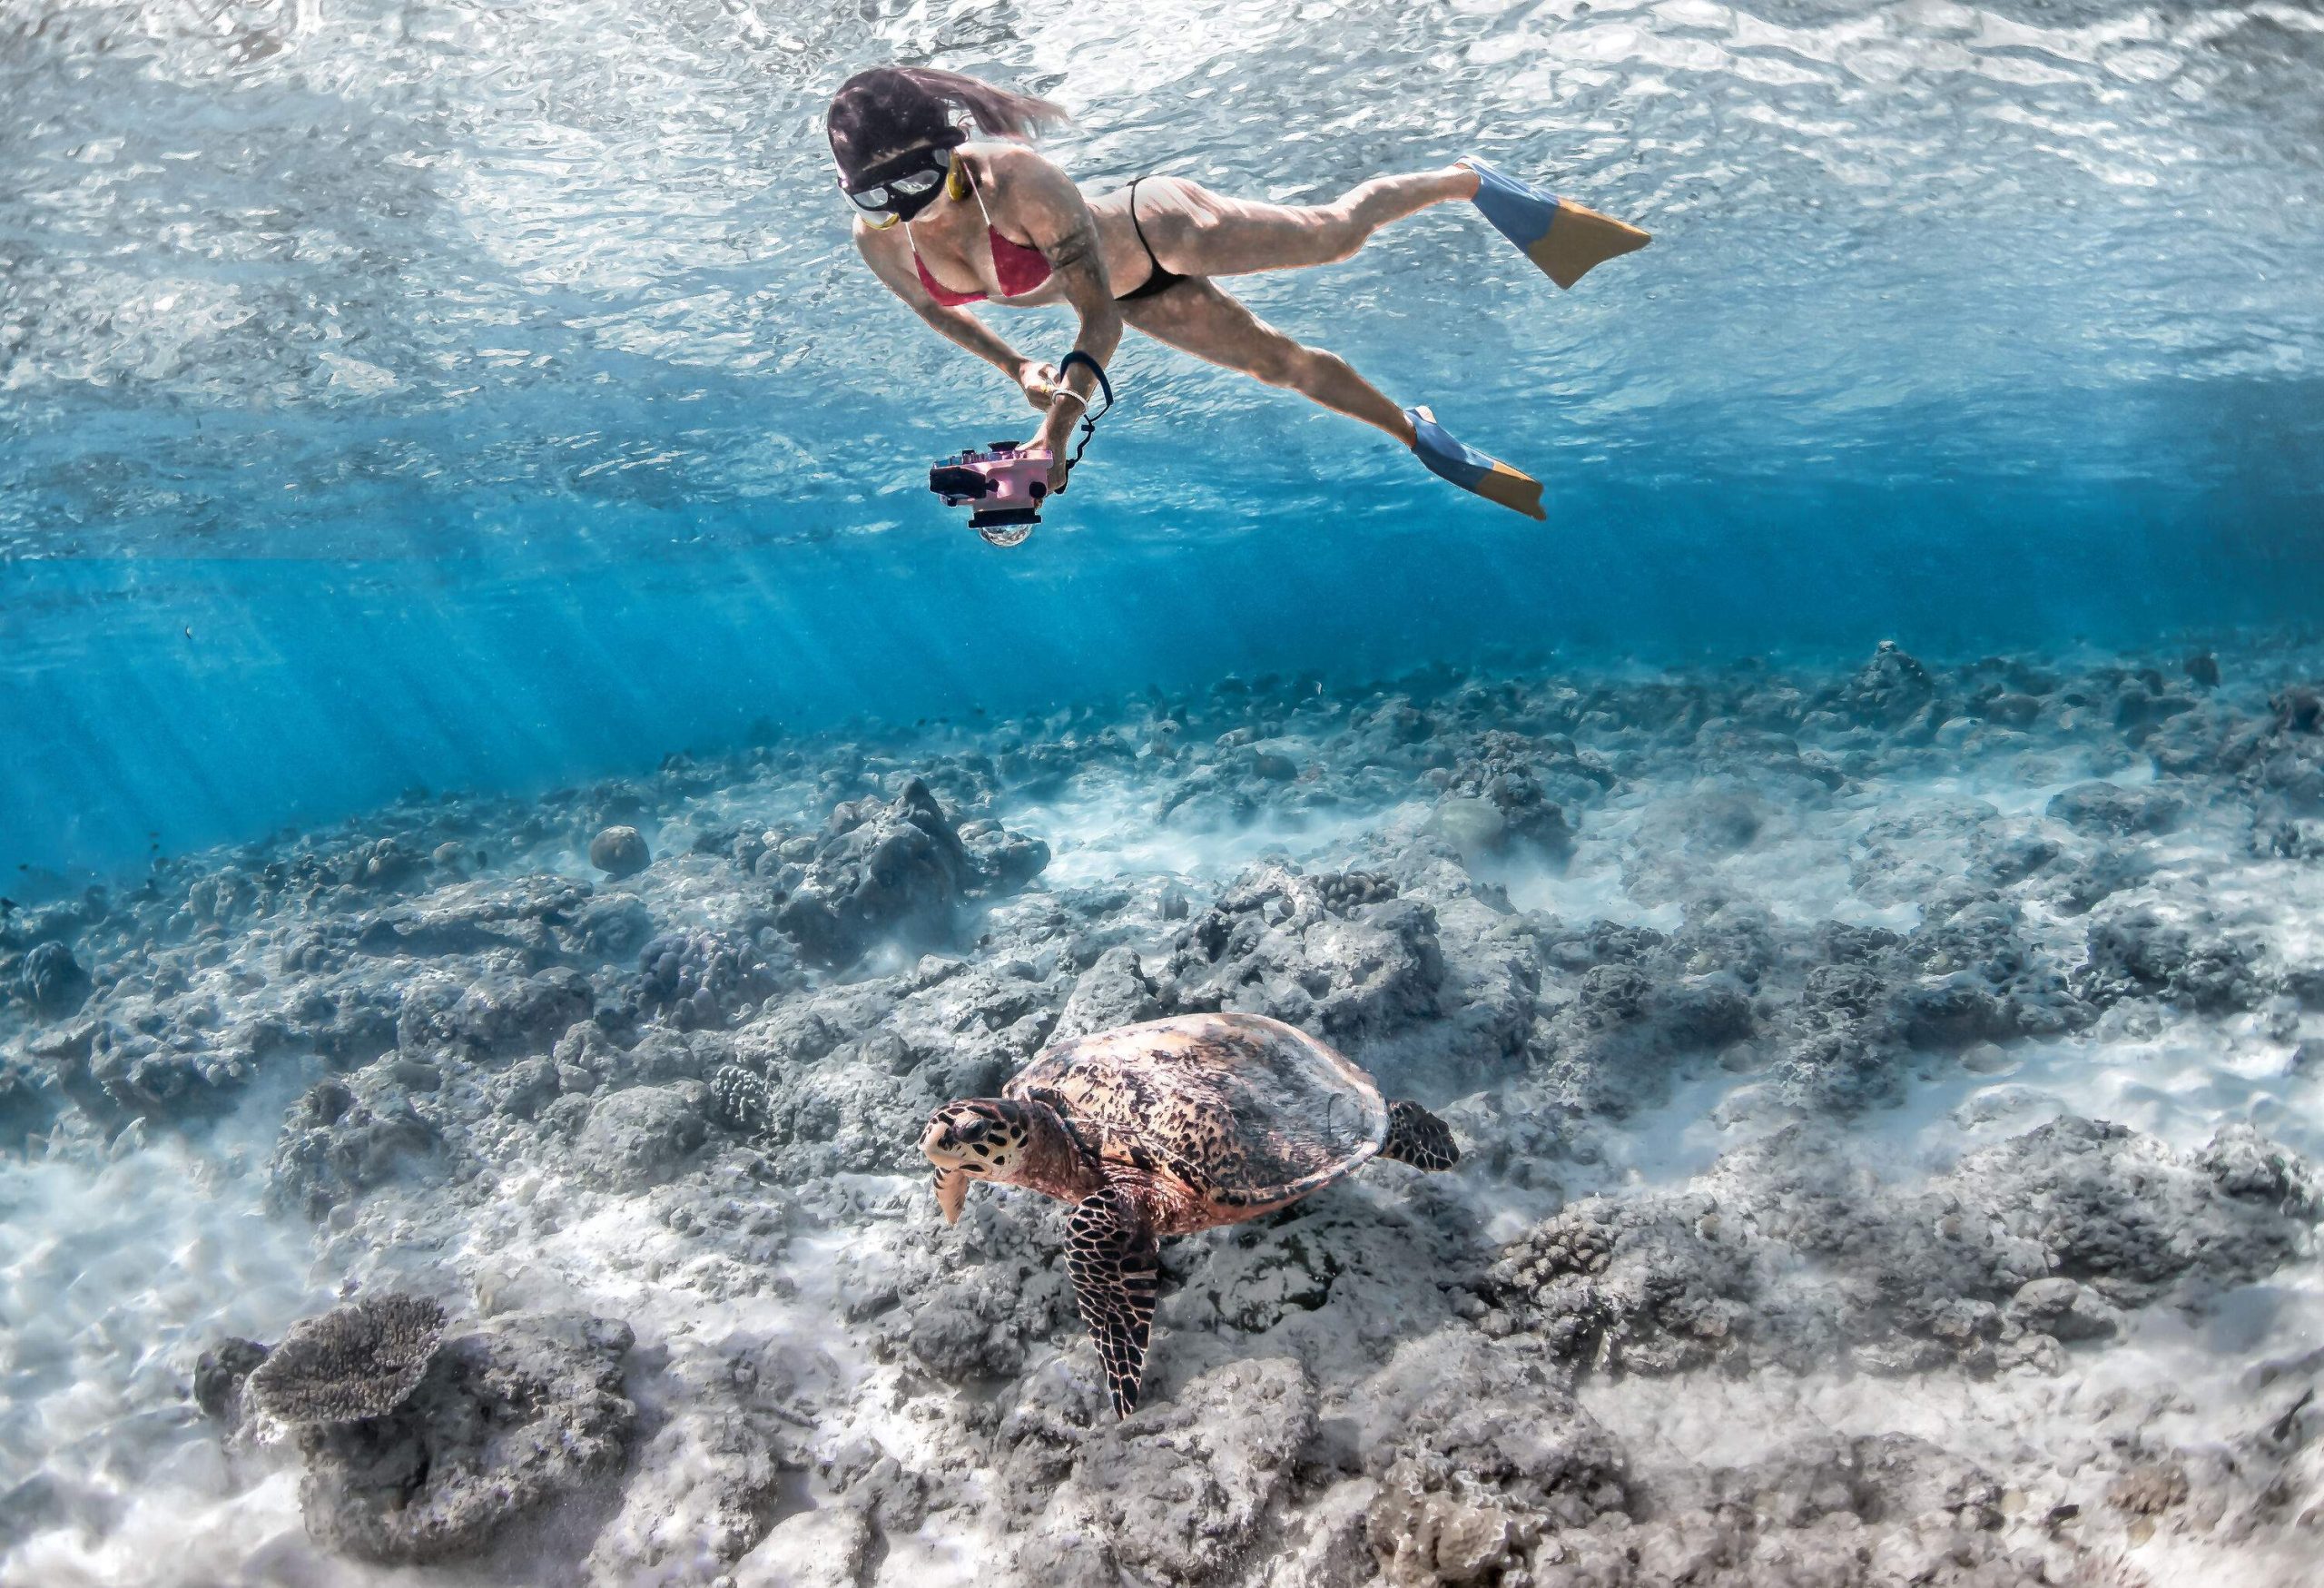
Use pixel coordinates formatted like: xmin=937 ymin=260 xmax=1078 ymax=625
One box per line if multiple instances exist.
xmin=1137 ymin=165 xmax=1476 ymax=277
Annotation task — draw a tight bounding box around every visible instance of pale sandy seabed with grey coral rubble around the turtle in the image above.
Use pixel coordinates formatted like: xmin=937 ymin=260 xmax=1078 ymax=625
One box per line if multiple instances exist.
xmin=0 ymin=639 xmax=2324 ymax=1588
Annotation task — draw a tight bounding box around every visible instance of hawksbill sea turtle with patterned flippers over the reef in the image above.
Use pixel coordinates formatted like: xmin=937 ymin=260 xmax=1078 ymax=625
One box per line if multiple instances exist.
xmin=921 ymin=1013 xmax=1460 ymax=1416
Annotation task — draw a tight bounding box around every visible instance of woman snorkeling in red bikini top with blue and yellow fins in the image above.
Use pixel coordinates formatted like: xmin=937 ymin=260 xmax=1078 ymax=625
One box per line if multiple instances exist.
xmin=825 ymin=67 xmax=1648 ymax=518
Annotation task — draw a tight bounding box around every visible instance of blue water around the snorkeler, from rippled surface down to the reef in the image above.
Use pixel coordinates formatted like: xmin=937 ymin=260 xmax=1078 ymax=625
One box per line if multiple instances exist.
xmin=0 ymin=0 xmax=2324 ymax=876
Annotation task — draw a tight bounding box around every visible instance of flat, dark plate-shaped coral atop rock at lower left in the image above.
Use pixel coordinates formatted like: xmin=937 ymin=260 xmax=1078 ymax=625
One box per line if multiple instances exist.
xmin=245 ymin=1290 xmax=444 ymax=1425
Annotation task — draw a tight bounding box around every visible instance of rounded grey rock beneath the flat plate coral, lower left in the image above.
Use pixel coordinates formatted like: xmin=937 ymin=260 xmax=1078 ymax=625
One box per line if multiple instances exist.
xmin=300 ymin=1314 xmax=636 ymax=1564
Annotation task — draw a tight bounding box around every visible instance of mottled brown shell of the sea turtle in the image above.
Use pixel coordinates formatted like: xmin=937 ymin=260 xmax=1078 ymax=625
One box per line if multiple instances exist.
xmin=1004 ymin=1013 xmax=1387 ymax=1216
